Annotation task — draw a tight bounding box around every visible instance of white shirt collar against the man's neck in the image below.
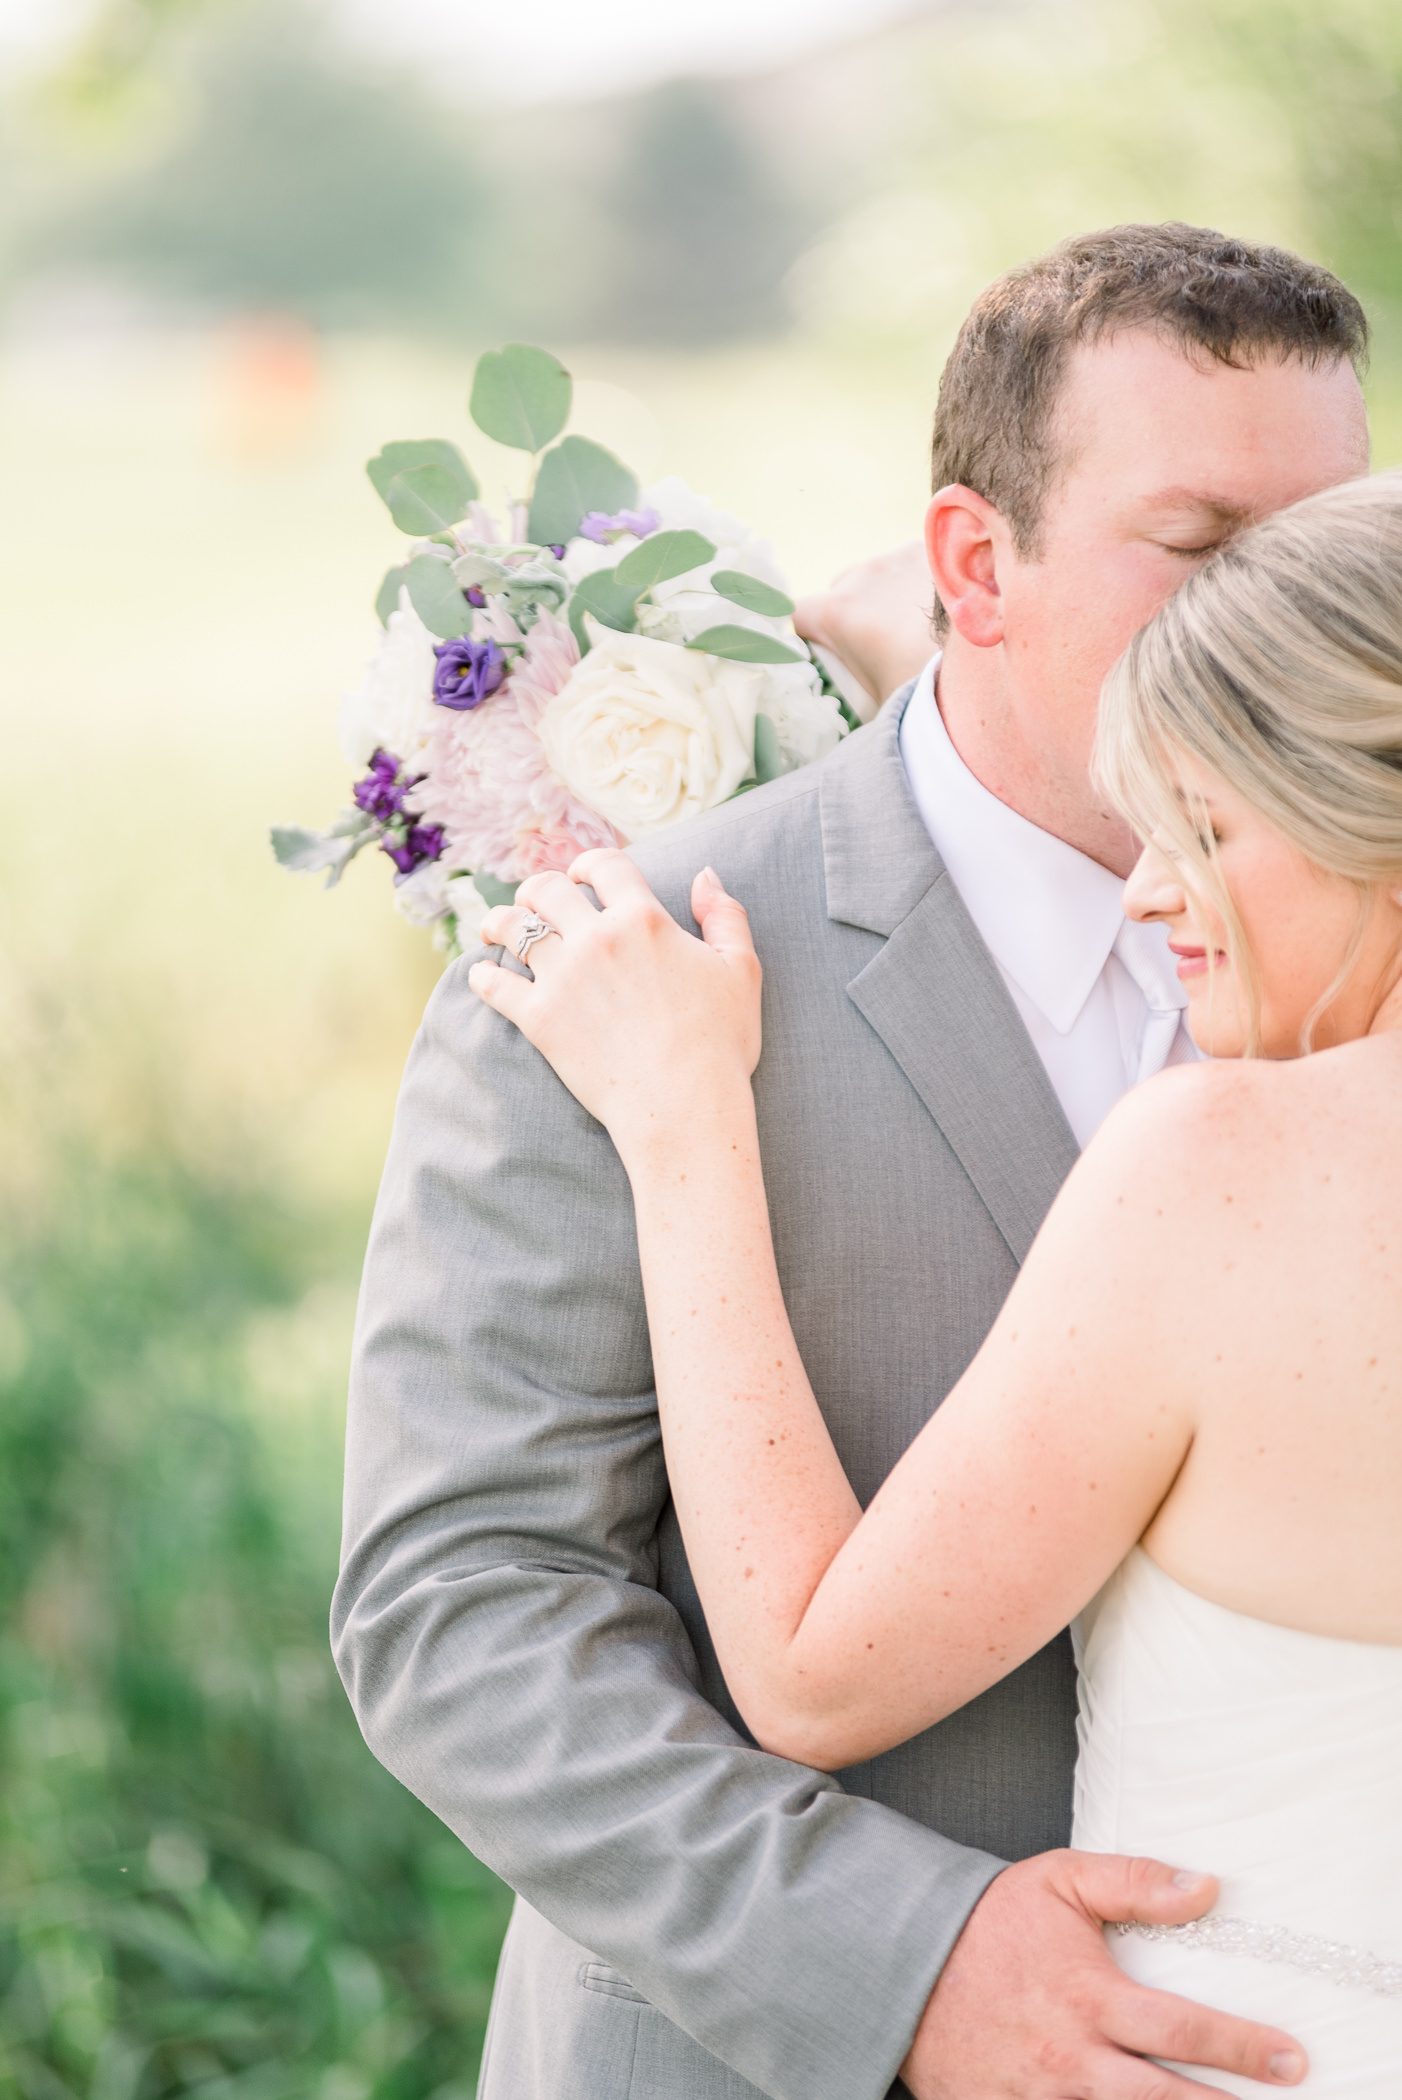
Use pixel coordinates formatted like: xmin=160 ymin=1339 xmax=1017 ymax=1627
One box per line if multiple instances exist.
xmin=900 ymin=655 xmax=1133 ymax=1035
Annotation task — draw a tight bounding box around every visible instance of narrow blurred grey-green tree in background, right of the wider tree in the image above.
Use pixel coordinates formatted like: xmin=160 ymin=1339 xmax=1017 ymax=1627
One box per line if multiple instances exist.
xmin=596 ymin=80 xmax=810 ymax=344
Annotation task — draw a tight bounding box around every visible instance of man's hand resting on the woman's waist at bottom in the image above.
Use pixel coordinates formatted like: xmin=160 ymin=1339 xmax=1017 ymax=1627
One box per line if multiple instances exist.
xmin=900 ymin=1852 xmax=1305 ymax=2100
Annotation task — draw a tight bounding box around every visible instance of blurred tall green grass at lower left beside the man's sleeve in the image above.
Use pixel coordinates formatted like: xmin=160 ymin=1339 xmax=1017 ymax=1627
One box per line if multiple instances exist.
xmin=0 ymin=1147 xmax=506 ymax=2100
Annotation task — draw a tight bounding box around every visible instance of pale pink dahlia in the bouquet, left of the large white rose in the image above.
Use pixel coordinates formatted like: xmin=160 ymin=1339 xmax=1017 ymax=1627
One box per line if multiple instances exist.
xmin=405 ymin=613 xmax=619 ymax=882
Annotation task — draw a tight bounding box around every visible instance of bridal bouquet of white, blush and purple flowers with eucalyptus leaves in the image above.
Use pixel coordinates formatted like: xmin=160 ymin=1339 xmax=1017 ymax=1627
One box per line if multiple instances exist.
xmin=273 ymin=342 xmax=858 ymax=953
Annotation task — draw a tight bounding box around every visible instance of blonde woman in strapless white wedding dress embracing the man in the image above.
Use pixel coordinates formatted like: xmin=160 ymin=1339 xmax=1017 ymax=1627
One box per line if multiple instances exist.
xmin=470 ymin=475 xmax=1402 ymax=2100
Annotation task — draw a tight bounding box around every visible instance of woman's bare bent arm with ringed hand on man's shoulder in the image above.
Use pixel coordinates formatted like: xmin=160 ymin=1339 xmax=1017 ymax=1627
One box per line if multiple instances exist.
xmin=472 ymin=855 xmax=1192 ymax=1768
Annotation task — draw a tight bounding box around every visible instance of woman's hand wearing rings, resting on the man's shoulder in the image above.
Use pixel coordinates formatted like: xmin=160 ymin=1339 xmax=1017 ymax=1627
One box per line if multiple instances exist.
xmin=468 ymin=848 xmax=760 ymax=1159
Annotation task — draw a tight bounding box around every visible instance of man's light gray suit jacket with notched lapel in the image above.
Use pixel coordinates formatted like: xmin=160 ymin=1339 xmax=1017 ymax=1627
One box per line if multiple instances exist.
xmin=334 ymin=695 xmax=1077 ymax=2100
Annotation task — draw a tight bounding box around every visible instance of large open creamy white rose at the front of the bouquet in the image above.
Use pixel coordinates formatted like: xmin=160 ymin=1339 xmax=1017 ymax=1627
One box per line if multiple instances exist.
xmin=539 ymin=613 xmax=764 ymax=840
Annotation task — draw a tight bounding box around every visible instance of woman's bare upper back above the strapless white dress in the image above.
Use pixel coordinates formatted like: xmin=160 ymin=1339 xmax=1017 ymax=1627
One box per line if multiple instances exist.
xmin=1133 ymin=1035 xmax=1402 ymax=1642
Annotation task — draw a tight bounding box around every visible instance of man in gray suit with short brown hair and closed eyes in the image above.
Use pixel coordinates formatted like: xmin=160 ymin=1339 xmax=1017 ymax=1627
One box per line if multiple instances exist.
xmin=334 ymin=227 xmax=1366 ymax=2100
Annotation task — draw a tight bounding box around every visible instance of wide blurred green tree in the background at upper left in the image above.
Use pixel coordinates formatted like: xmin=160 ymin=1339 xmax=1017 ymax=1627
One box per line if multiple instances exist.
xmin=29 ymin=8 xmax=487 ymax=334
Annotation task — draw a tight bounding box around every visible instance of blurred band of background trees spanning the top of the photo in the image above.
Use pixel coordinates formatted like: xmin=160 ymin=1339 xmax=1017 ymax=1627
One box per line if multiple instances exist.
xmin=10 ymin=0 xmax=1402 ymax=365
